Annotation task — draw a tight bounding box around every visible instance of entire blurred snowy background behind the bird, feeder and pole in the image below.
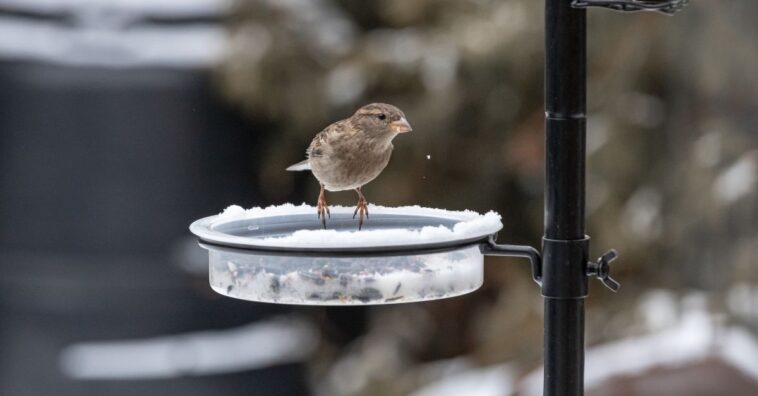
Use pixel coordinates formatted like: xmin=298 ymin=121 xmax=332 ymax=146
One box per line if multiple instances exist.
xmin=0 ymin=0 xmax=758 ymax=396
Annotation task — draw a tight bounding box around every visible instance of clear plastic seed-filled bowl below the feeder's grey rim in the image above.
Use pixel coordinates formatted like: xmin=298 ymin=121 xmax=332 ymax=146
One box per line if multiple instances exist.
xmin=206 ymin=245 xmax=483 ymax=305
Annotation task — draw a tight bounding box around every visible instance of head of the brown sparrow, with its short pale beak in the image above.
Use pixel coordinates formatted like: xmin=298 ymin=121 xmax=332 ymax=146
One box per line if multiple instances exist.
xmin=351 ymin=103 xmax=413 ymax=138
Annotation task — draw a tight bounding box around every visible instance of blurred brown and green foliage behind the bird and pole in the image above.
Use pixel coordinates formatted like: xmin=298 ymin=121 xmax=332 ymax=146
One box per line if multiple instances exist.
xmin=218 ymin=0 xmax=758 ymax=395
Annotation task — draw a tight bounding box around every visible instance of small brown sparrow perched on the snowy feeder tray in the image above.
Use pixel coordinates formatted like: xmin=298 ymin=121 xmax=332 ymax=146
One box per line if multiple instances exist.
xmin=287 ymin=103 xmax=412 ymax=230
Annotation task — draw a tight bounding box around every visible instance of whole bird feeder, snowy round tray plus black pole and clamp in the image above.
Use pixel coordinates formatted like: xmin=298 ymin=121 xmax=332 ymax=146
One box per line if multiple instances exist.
xmin=191 ymin=0 xmax=687 ymax=396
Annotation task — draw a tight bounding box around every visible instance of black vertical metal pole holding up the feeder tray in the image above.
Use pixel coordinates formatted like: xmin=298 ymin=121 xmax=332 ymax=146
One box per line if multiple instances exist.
xmin=542 ymin=0 xmax=589 ymax=396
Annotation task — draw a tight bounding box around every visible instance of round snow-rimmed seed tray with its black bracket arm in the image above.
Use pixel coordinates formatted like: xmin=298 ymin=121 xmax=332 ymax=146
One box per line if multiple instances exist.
xmin=190 ymin=205 xmax=539 ymax=305
